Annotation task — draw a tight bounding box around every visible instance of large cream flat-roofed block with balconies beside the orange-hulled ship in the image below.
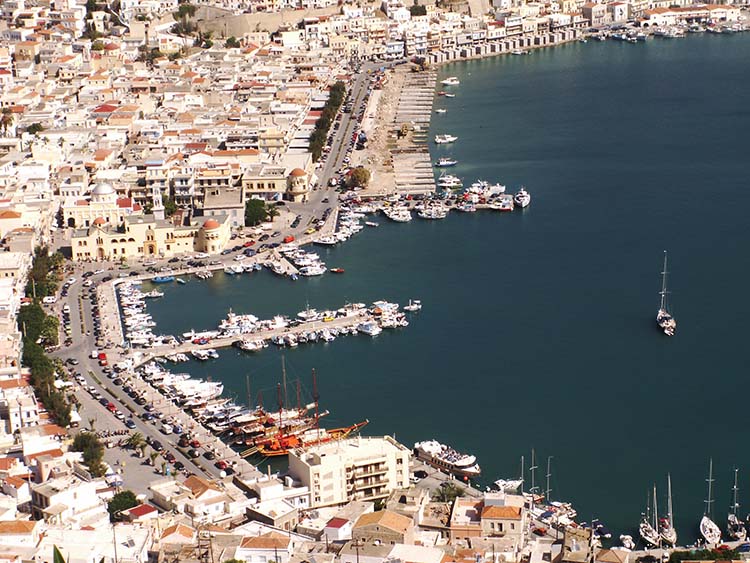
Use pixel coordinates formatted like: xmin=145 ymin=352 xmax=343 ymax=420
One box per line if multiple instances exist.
xmin=289 ymin=436 xmax=410 ymax=508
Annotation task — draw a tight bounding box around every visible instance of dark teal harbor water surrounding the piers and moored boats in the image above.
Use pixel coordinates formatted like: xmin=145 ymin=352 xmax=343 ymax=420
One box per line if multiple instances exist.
xmin=144 ymin=34 xmax=750 ymax=544
